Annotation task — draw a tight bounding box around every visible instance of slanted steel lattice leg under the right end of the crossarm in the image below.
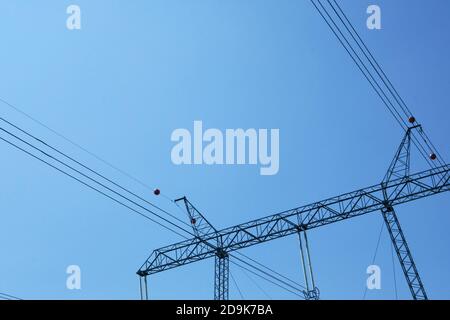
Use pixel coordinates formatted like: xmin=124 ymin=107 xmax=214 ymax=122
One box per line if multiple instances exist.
xmin=381 ymin=205 xmax=428 ymax=300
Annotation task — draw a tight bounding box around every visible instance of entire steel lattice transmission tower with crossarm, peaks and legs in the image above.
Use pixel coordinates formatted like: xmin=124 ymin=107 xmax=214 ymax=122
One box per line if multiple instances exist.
xmin=137 ymin=126 xmax=450 ymax=300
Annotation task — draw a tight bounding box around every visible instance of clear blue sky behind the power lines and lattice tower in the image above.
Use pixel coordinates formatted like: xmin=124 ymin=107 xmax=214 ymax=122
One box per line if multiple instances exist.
xmin=0 ymin=0 xmax=450 ymax=299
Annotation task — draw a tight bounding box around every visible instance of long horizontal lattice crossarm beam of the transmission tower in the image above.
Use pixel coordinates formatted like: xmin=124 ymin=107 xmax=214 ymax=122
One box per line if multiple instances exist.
xmin=138 ymin=164 xmax=450 ymax=276
